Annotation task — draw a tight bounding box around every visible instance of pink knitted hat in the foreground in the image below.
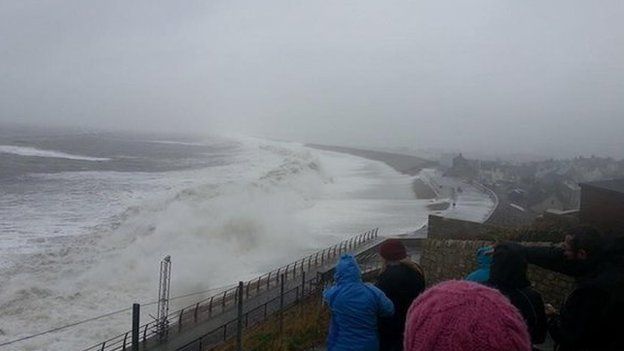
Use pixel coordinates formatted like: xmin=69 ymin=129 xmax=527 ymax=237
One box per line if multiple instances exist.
xmin=404 ymin=280 xmax=531 ymax=351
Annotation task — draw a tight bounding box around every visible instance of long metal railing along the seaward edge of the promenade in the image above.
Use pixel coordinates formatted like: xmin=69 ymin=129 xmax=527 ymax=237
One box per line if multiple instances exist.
xmin=83 ymin=228 xmax=379 ymax=351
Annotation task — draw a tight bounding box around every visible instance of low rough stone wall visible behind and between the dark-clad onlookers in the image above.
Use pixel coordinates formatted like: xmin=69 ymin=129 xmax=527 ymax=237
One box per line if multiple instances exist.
xmin=420 ymin=239 xmax=572 ymax=306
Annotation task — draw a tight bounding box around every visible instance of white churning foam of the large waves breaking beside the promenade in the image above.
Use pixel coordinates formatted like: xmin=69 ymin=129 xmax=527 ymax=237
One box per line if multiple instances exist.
xmin=0 ymin=140 xmax=327 ymax=350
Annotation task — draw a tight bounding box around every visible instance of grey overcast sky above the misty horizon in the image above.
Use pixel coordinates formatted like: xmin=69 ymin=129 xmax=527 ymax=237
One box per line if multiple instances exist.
xmin=0 ymin=0 xmax=624 ymax=157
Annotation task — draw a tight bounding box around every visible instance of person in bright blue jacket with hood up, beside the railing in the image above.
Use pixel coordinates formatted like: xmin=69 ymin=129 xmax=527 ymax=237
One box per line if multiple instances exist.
xmin=323 ymin=255 xmax=394 ymax=351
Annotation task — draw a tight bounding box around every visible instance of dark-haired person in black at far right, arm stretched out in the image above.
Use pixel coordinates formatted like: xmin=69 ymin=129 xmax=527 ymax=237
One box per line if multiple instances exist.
xmin=508 ymin=227 xmax=624 ymax=351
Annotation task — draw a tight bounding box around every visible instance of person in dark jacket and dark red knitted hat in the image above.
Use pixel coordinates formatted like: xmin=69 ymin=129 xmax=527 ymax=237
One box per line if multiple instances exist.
xmin=377 ymin=239 xmax=425 ymax=351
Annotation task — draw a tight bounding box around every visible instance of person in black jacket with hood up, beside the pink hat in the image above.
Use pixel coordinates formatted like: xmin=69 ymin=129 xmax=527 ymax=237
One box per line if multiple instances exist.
xmin=487 ymin=244 xmax=547 ymax=345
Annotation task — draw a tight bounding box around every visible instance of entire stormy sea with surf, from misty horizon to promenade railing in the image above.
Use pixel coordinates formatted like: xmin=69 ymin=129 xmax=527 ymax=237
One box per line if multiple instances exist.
xmin=0 ymin=131 xmax=488 ymax=350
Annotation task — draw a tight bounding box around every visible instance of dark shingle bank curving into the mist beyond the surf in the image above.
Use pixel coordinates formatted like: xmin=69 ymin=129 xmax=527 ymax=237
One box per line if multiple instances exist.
xmin=306 ymin=144 xmax=437 ymax=200
